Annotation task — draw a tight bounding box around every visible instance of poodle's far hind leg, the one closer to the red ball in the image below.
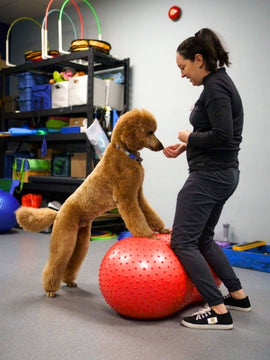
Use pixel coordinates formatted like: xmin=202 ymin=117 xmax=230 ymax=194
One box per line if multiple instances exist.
xmin=62 ymin=223 xmax=91 ymax=287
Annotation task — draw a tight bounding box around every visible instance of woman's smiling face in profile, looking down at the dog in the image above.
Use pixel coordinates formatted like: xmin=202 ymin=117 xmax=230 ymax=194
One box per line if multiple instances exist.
xmin=176 ymin=52 xmax=210 ymax=86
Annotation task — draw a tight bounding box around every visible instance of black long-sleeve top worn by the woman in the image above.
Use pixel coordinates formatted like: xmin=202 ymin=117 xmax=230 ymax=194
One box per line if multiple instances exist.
xmin=187 ymin=68 xmax=244 ymax=171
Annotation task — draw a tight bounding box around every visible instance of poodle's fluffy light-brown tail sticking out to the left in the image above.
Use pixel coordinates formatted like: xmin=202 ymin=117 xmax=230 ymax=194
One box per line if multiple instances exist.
xmin=15 ymin=206 xmax=57 ymax=232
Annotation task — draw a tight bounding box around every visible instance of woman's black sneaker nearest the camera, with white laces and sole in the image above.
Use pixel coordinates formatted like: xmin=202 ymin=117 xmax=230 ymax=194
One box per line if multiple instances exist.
xmin=182 ymin=308 xmax=233 ymax=330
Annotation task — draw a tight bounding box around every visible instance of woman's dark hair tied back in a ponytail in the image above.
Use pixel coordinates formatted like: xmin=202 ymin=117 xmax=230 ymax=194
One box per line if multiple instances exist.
xmin=177 ymin=28 xmax=230 ymax=72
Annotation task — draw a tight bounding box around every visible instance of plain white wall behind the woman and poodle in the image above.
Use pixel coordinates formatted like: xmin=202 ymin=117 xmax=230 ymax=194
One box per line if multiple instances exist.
xmin=11 ymin=0 xmax=270 ymax=243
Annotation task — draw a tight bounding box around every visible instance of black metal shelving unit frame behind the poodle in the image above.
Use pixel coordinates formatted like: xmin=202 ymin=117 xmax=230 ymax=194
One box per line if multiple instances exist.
xmin=0 ymin=48 xmax=130 ymax=194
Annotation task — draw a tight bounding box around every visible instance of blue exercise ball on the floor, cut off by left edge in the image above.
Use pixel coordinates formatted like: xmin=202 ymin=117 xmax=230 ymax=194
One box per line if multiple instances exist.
xmin=0 ymin=190 xmax=20 ymax=233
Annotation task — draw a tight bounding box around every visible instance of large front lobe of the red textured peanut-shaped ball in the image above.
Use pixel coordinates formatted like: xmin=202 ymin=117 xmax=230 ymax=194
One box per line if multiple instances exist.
xmin=99 ymin=237 xmax=192 ymax=319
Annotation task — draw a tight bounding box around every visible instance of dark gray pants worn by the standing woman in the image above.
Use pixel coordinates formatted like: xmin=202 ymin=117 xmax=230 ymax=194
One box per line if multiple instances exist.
xmin=171 ymin=168 xmax=242 ymax=306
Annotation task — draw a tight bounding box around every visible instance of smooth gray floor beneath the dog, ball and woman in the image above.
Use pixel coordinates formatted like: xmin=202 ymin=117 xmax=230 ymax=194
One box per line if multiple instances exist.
xmin=0 ymin=230 xmax=270 ymax=360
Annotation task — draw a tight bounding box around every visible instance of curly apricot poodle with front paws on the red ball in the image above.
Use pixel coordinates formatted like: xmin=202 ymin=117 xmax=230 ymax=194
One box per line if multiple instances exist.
xmin=16 ymin=109 xmax=169 ymax=297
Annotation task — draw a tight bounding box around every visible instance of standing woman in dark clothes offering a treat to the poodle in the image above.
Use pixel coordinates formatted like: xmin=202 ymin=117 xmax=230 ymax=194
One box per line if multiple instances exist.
xmin=164 ymin=28 xmax=251 ymax=329
